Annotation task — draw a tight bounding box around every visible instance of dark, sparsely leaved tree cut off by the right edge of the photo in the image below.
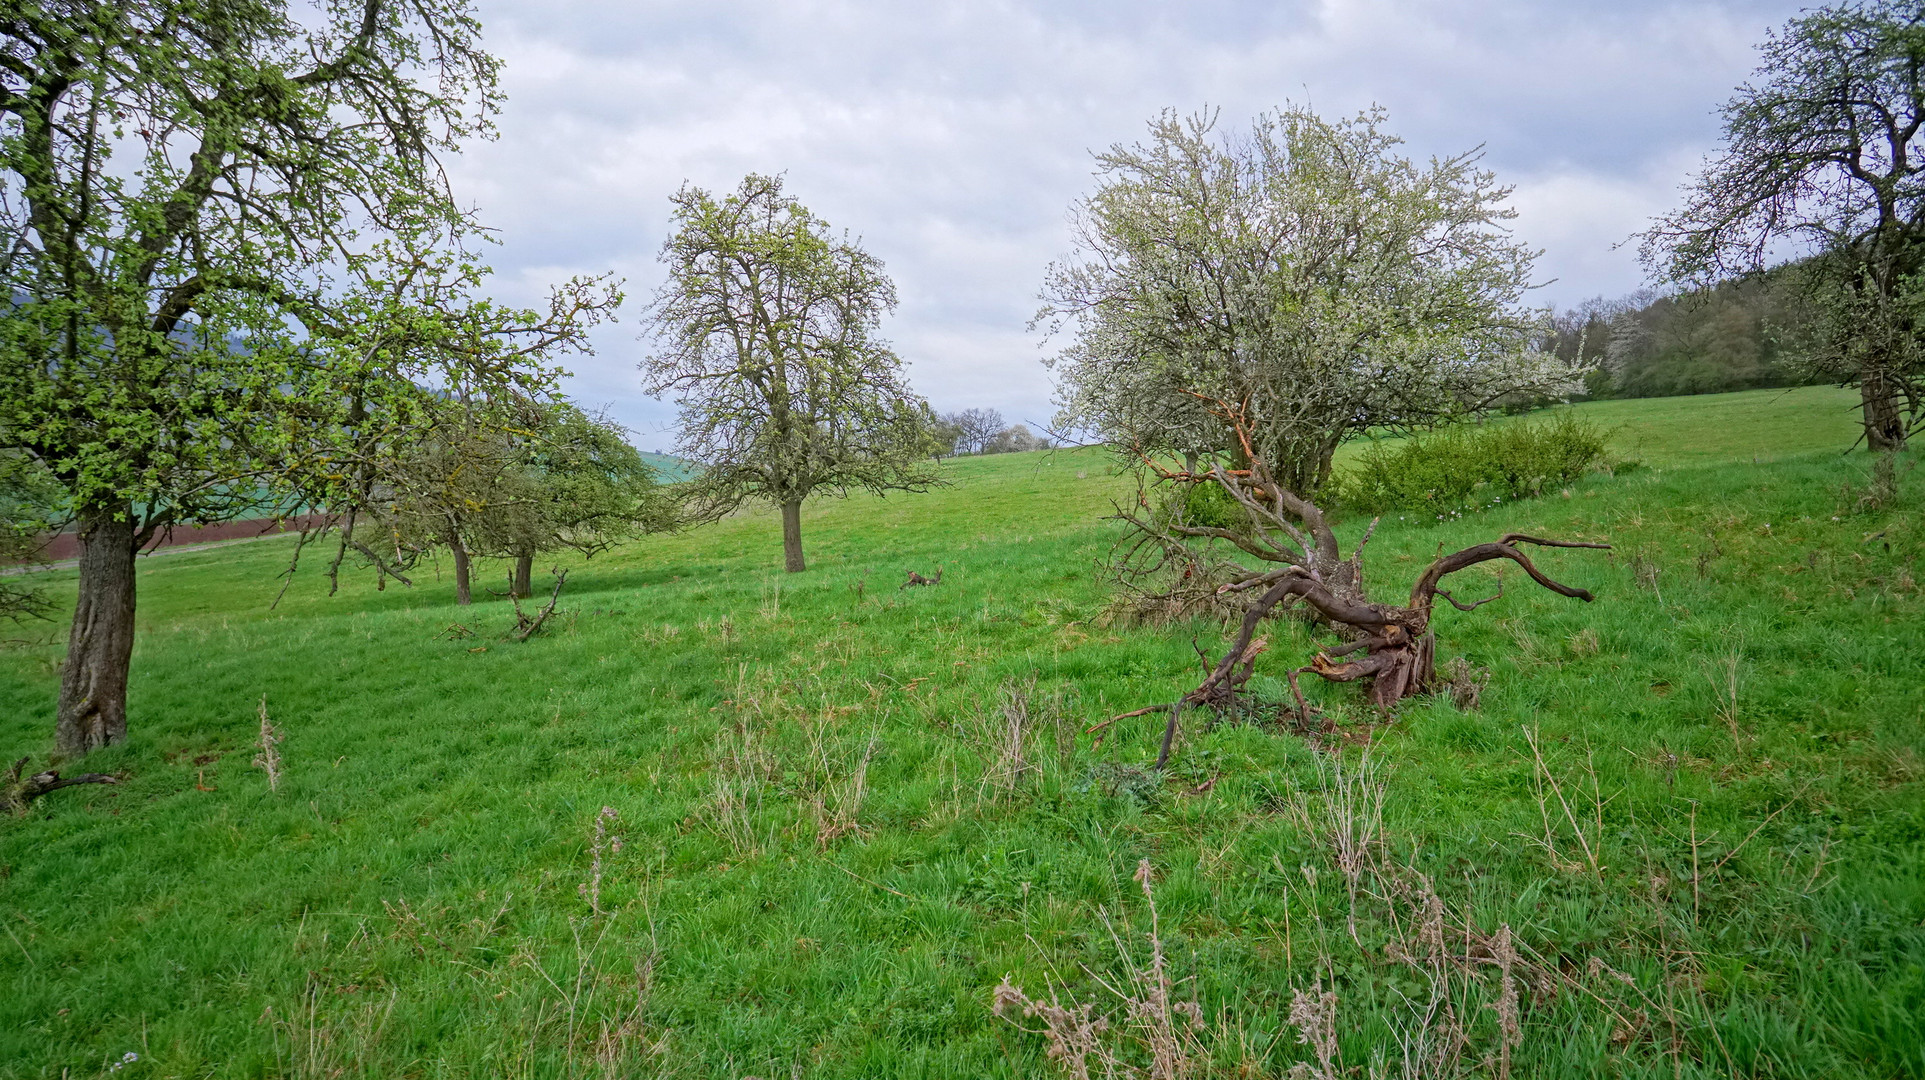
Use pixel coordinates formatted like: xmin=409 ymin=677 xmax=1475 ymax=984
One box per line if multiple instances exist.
xmin=1642 ymin=0 xmax=1925 ymax=450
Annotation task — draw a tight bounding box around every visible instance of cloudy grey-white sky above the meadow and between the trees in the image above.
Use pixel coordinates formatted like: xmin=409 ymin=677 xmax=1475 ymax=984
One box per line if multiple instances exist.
xmin=450 ymin=0 xmax=1798 ymax=449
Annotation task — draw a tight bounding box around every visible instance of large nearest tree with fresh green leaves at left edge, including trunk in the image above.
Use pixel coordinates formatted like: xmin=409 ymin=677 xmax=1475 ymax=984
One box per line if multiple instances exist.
xmin=0 ymin=0 xmax=614 ymax=755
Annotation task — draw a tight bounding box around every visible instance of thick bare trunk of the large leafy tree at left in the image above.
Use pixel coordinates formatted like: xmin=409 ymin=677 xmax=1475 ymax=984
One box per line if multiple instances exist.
xmin=54 ymin=502 xmax=135 ymax=757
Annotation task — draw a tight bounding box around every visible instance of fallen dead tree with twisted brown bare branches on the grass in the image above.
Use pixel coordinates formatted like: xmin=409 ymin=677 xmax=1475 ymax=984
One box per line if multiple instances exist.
xmin=1113 ymin=399 xmax=1611 ymax=768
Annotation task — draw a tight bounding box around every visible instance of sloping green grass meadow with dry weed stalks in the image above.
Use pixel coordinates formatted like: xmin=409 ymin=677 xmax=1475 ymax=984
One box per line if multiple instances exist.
xmin=0 ymin=389 xmax=1925 ymax=1080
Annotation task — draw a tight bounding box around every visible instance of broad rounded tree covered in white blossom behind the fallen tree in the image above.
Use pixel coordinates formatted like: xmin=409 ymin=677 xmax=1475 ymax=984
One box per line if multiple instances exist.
xmin=1038 ymin=106 xmax=1580 ymax=497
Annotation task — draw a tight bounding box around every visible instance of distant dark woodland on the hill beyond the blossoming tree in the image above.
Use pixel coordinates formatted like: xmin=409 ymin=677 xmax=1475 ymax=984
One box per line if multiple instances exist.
xmin=1542 ymin=270 xmax=1825 ymax=399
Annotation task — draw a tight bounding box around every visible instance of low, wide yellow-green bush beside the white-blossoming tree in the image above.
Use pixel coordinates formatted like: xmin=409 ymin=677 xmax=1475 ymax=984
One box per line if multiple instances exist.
xmin=1338 ymin=410 xmax=1609 ymax=514
